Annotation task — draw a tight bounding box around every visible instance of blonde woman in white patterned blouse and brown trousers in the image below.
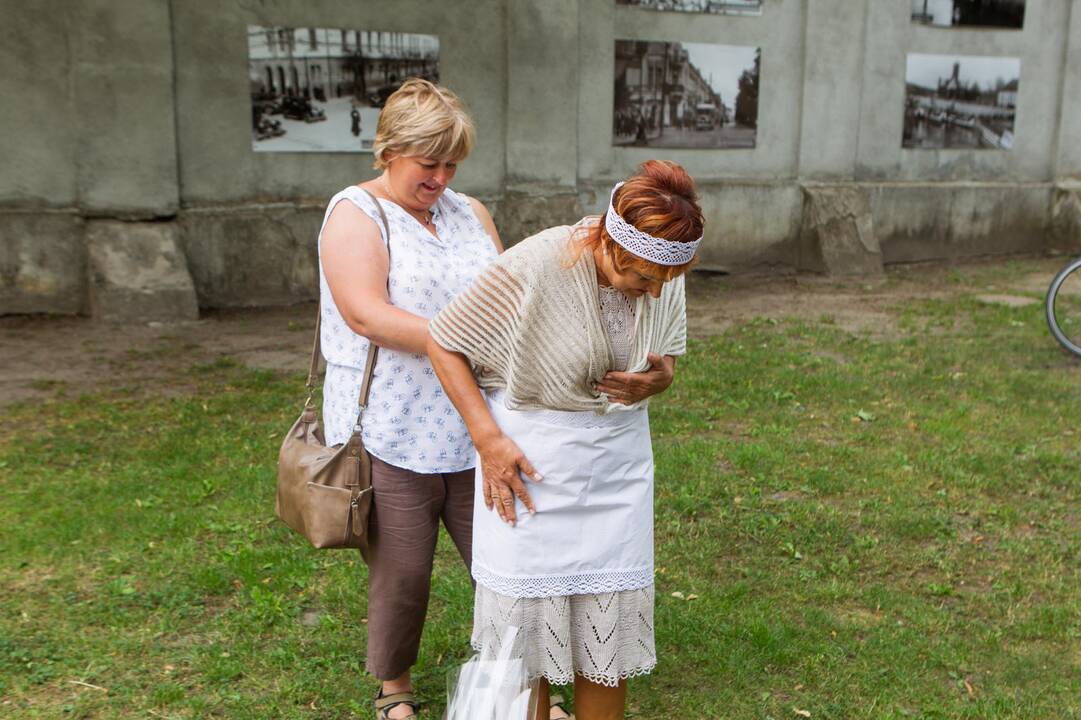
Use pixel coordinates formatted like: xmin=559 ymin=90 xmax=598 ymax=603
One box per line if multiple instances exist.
xmin=319 ymin=79 xmax=503 ymax=719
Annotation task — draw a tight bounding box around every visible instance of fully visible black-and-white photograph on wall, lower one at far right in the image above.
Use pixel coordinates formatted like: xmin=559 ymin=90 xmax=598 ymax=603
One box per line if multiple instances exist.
xmin=902 ymin=53 xmax=1020 ymax=150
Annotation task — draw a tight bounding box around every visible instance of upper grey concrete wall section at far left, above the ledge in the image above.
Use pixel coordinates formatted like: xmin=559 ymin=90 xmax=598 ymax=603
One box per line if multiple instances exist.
xmin=0 ymin=0 xmax=179 ymax=216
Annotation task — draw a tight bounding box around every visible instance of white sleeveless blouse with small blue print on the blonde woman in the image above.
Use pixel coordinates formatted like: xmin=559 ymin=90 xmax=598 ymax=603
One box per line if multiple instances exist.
xmin=319 ymin=186 xmax=496 ymax=472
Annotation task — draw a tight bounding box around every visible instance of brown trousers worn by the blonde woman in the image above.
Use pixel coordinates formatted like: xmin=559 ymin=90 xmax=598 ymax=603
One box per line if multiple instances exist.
xmin=366 ymin=456 xmax=475 ymax=680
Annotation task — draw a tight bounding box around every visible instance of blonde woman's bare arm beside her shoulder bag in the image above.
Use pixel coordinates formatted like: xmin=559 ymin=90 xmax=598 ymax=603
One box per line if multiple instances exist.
xmin=320 ymin=201 xmax=428 ymax=355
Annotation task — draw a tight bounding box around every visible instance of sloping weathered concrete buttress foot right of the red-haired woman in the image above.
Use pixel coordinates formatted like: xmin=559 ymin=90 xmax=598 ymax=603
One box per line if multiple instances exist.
xmin=800 ymin=185 xmax=882 ymax=276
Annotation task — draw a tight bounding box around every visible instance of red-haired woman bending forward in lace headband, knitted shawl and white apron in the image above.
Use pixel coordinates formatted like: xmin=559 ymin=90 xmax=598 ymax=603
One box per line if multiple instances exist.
xmin=428 ymin=160 xmax=703 ymax=720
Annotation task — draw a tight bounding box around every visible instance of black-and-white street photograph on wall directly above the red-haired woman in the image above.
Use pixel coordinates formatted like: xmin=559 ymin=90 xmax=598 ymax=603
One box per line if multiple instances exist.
xmin=612 ymin=40 xmax=762 ymax=148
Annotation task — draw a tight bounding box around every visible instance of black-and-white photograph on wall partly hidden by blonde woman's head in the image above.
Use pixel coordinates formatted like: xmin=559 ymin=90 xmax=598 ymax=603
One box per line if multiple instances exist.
xmin=248 ymin=25 xmax=439 ymax=152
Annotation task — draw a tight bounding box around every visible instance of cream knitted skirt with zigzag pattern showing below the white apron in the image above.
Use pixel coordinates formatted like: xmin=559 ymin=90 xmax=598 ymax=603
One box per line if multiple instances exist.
xmin=472 ymin=585 xmax=657 ymax=688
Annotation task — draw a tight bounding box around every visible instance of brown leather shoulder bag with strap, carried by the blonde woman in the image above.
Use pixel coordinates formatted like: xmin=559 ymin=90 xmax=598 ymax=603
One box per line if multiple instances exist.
xmin=275 ymin=188 xmax=390 ymax=555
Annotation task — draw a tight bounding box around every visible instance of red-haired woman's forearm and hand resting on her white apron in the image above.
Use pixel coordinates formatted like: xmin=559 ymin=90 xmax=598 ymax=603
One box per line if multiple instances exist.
xmin=428 ymin=338 xmax=543 ymax=526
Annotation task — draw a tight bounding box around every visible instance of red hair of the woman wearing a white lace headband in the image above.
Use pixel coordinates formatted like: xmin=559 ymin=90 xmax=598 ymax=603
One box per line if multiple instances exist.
xmin=571 ymin=160 xmax=705 ymax=281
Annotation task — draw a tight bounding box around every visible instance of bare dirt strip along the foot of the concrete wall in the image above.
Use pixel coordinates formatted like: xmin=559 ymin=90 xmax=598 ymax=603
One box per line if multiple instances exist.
xmin=0 ymin=257 xmax=1066 ymax=406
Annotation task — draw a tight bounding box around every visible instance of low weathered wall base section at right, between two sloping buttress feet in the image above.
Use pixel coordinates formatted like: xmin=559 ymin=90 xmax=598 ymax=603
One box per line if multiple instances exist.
xmin=867 ymin=183 xmax=1052 ymax=263
